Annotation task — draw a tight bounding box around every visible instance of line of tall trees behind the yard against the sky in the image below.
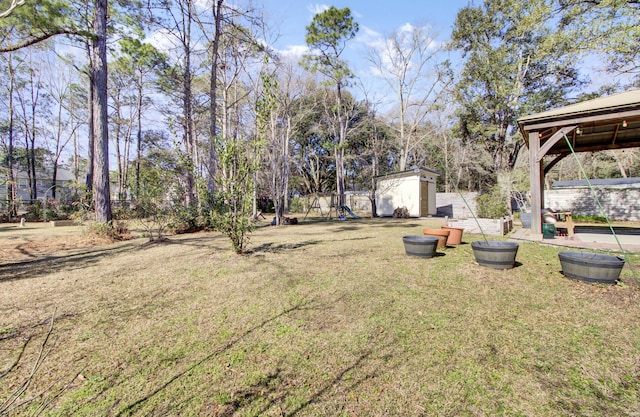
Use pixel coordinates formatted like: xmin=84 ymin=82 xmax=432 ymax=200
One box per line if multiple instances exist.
xmin=0 ymin=0 xmax=640 ymax=245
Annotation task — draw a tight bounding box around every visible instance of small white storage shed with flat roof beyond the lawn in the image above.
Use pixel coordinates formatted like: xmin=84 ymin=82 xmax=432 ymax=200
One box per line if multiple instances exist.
xmin=376 ymin=168 xmax=440 ymax=217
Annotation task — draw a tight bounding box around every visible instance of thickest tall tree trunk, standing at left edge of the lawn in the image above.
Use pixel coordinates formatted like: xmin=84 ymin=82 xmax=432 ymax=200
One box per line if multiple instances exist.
xmin=92 ymin=0 xmax=112 ymax=223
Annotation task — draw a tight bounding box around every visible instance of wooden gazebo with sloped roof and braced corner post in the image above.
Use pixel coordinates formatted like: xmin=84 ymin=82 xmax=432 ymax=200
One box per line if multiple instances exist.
xmin=518 ymin=90 xmax=640 ymax=239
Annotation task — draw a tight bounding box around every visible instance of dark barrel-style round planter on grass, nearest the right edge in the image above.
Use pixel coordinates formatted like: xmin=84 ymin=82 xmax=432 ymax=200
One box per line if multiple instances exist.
xmin=558 ymin=252 xmax=624 ymax=284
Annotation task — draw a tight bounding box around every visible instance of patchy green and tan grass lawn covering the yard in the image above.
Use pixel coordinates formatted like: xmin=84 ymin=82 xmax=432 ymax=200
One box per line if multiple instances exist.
xmin=0 ymin=219 xmax=640 ymax=416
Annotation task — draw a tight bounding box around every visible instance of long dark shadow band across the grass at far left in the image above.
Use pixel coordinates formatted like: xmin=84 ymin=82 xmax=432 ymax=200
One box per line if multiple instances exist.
xmin=0 ymin=243 xmax=138 ymax=282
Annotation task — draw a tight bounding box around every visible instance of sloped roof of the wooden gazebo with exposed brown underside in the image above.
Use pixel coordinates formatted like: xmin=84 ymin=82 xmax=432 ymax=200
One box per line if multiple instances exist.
xmin=518 ymin=90 xmax=640 ymax=155
